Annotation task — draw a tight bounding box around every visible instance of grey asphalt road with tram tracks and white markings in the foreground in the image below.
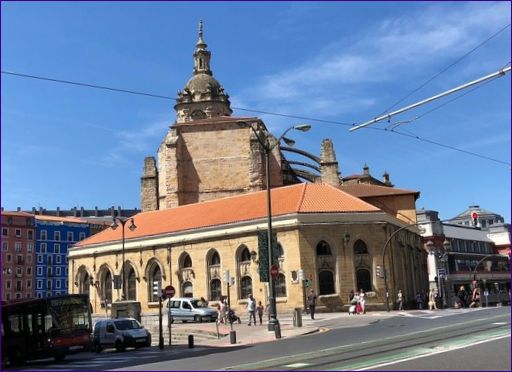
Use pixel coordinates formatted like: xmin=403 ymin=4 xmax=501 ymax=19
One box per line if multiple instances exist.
xmin=10 ymin=307 xmax=511 ymax=371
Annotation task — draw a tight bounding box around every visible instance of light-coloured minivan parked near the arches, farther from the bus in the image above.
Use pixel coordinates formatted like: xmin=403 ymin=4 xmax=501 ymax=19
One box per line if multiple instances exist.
xmin=167 ymin=297 xmax=217 ymax=323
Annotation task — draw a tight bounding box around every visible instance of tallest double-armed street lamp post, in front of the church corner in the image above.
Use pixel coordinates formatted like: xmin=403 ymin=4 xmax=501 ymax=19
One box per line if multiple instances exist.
xmin=248 ymin=124 xmax=311 ymax=338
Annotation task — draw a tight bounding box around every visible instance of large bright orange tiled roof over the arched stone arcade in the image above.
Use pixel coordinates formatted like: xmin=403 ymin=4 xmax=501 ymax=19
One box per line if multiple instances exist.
xmin=77 ymin=183 xmax=381 ymax=246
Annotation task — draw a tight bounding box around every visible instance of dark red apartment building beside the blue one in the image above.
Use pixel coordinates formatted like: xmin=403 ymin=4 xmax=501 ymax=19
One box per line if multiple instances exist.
xmin=1 ymin=211 xmax=36 ymax=301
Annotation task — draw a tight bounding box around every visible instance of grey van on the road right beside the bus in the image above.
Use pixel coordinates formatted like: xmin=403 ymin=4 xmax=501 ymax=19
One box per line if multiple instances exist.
xmin=93 ymin=318 xmax=151 ymax=353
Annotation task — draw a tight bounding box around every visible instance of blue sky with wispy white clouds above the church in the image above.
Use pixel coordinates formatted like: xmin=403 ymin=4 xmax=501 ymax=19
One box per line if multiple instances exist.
xmin=1 ymin=2 xmax=511 ymax=222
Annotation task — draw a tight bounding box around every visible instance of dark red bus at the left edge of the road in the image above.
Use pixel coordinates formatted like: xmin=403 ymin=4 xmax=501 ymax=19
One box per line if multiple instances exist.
xmin=2 ymin=294 xmax=92 ymax=365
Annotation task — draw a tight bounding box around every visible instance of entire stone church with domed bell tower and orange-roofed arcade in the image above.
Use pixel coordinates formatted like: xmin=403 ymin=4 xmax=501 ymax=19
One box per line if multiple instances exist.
xmin=68 ymin=23 xmax=428 ymax=314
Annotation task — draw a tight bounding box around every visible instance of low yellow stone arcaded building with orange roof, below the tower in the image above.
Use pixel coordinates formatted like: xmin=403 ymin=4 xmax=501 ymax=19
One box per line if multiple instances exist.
xmin=69 ymin=184 xmax=428 ymax=313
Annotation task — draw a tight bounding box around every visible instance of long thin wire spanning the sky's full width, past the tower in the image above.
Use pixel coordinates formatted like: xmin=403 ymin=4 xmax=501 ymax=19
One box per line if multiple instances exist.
xmin=1 ymin=70 xmax=510 ymax=166
